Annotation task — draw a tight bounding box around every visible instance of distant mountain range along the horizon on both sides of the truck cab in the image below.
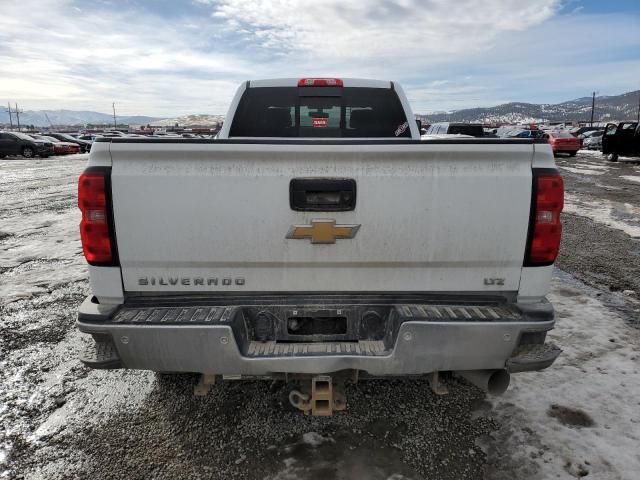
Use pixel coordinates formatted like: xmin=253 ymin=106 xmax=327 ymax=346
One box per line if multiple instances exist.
xmin=5 ymin=90 xmax=640 ymax=127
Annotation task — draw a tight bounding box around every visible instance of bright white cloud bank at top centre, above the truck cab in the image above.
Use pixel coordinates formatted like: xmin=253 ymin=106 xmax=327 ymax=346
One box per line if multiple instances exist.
xmin=211 ymin=0 xmax=560 ymax=61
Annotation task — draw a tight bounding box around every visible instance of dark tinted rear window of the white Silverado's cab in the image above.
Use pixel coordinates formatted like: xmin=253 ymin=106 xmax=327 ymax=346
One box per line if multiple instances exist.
xmin=229 ymin=87 xmax=411 ymax=138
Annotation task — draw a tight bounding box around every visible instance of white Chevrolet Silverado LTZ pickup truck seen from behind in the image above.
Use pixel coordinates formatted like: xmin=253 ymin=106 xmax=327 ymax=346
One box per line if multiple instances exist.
xmin=77 ymin=78 xmax=563 ymax=414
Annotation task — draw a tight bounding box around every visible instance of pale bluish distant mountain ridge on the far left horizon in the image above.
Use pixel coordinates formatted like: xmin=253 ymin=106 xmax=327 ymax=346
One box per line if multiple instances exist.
xmin=0 ymin=109 xmax=159 ymax=127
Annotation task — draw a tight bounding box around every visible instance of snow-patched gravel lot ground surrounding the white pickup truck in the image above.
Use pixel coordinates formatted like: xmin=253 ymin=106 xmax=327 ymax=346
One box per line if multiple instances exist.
xmin=0 ymin=154 xmax=640 ymax=480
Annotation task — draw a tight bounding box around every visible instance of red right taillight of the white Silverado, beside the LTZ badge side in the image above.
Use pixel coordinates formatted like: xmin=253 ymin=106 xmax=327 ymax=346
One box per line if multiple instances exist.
xmin=525 ymin=170 xmax=564 ymax=267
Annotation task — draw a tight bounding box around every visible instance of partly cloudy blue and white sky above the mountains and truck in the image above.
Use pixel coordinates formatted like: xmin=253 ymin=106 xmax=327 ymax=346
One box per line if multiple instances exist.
xmin=0 ymin=0 xmax=640 ymax=117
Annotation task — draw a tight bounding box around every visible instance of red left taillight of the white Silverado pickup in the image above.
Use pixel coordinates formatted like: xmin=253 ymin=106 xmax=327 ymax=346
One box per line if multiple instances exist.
xmin=78 ymin=167 xmax=117 ymax=265
